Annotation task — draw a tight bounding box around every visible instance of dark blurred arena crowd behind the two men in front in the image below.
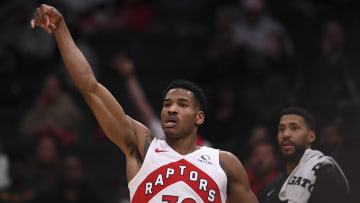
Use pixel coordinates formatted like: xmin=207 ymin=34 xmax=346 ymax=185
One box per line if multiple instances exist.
xmin=0 ymin=0 xmax=360 ymax=203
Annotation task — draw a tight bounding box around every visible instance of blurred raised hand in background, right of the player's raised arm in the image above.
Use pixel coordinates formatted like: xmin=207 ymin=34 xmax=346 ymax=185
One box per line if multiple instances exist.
xmin=112 ymin=53 xmax=134 ymax=78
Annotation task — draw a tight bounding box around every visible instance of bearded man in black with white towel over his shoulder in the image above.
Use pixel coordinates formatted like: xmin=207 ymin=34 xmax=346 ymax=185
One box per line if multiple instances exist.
xmin=259 ymin=107 xmax=350 ymax=203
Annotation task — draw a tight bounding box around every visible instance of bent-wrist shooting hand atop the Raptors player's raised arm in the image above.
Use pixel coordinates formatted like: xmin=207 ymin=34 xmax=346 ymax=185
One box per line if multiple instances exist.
xmin=30 ymin=4 xmax=62 ymax=34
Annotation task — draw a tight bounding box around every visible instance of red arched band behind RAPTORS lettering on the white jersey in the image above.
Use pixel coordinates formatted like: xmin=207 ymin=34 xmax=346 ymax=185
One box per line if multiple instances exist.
xmin=131 ymin=159 xmax=222 ymax=203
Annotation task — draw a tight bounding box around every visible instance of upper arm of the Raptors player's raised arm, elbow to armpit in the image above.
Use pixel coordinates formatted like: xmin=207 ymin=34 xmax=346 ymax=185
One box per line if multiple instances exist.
xmin=84 ymin=83 xmax=136 ymax=153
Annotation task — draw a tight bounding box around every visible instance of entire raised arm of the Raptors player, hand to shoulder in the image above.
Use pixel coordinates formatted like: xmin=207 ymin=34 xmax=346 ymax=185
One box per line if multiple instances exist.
xmin=31 ymin=4 xmax=149 ymax=158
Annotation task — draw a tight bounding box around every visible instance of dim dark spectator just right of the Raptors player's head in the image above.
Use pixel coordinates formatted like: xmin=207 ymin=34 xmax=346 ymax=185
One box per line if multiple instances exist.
xmin=204 ymin=80 xmax=247 ymax=157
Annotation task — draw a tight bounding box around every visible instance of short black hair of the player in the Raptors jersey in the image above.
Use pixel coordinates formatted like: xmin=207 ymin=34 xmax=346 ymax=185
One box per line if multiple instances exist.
xmin=163 ymin=80 xmax=207 ymax=112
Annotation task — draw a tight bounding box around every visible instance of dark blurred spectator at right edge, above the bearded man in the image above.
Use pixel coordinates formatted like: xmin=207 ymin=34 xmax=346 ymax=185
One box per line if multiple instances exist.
xmin=300 ymin=20 xmax=360 ymax=118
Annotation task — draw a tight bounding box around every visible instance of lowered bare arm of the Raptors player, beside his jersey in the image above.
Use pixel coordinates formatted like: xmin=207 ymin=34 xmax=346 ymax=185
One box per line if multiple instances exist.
xmin=220 ymin=151 xmax=258 ymax=203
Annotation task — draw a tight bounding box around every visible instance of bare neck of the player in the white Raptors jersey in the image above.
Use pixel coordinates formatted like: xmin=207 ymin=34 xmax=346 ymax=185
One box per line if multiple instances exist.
xmin=166 ymin=135 xmax=200 ymax=155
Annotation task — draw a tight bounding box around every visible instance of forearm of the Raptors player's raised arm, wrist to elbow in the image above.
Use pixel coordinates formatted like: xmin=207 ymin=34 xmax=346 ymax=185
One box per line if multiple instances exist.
xmin=54 ymin=19 xmax=97 ymax=93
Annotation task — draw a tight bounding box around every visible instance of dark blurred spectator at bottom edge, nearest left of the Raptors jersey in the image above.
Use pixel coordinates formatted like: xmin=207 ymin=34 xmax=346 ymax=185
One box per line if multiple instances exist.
xmin=58 ymin=156 xmax=100 ymax=203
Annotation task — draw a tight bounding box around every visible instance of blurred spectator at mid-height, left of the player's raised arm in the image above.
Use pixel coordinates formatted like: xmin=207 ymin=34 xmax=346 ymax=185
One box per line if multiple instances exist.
xmin=20 ymin=75 xmax=82 ymax=139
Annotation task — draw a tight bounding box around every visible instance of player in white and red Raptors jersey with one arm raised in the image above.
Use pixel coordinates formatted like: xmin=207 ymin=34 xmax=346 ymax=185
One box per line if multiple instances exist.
xmin=31 ymin=4 xmax=257 ymax=203
